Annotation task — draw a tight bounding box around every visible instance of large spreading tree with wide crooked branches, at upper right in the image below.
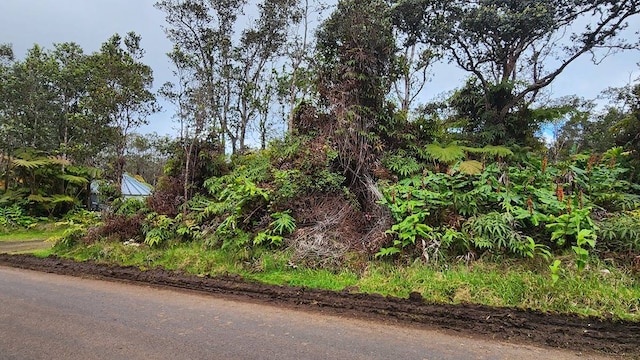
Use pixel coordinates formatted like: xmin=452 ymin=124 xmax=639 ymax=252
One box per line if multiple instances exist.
xmin=401 ymin=0 xmax=640 ymax=144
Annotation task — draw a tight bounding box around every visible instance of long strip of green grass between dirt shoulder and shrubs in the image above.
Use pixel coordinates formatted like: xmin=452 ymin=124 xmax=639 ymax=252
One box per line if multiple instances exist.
xmin=52 ymin=242 xmax=640 ymax=321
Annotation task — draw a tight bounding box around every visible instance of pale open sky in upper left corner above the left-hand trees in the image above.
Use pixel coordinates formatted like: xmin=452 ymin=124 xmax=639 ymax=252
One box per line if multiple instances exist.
xmin=0 ymin=0 xmax=177 ymax=135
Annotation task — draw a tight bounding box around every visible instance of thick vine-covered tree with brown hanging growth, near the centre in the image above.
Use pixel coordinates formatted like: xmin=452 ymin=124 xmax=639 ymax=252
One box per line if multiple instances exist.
xmin=316 ymin=0 xmax=395 ymax=195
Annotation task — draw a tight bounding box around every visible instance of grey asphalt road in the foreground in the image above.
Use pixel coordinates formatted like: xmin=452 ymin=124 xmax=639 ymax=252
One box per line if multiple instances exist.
xmin=0 ymin=267 xmax=601 ymax=360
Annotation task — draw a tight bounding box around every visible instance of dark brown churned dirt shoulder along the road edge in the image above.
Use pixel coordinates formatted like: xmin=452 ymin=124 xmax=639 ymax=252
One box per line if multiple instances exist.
xmin=0 ymin=254 xmax=640 ymax=357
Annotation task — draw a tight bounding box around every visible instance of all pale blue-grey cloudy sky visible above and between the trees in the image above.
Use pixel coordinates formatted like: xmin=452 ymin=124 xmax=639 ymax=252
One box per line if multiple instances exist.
xmin=0 ymin=0 xmax=640 ymax=135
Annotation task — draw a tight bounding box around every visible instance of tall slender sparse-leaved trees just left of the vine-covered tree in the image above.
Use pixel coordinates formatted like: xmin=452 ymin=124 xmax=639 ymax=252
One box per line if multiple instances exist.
xmin=156 ymin=0 xmax=298 ymax=153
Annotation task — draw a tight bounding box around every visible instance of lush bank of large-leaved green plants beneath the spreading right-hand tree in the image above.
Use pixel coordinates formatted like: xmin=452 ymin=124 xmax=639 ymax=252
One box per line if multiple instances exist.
xmin=380 ymin=147 xmax=640 ymax=266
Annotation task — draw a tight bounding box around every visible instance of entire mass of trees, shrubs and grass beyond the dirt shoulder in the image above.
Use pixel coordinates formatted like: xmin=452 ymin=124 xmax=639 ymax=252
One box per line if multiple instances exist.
xmin=0 ymin=0 xmax=640 ymax=320
